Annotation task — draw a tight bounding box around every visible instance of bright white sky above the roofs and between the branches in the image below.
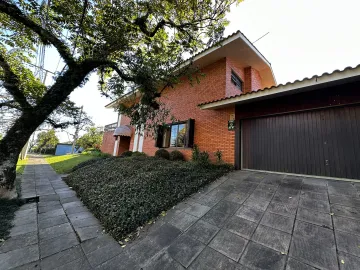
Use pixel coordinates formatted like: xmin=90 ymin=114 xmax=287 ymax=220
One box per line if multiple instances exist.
xmin=38 ymin=0 xmax=360 ymax=142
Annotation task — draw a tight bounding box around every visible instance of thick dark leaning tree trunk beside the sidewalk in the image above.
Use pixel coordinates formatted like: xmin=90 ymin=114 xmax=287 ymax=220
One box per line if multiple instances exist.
xmin=0 ymin=62 xmax=99 ymax=189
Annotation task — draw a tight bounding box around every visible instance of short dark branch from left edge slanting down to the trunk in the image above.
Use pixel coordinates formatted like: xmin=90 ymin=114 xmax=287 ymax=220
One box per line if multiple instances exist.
xmin=0 ymin=52 xmax=32 ymax=110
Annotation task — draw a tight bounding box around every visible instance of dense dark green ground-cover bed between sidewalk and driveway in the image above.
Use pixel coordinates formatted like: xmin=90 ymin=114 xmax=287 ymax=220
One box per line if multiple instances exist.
xmin=66 ymin=157 xmax=230 ymax=240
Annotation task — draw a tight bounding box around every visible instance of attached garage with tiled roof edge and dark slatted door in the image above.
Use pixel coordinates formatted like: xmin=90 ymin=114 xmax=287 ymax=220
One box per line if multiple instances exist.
xmin=199 ymin=65 xmax=360 ymax=180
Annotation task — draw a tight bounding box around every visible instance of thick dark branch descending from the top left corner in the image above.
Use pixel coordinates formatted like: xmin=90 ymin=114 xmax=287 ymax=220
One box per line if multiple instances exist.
xmin=0 ymin=0 xmax=75 ymax=66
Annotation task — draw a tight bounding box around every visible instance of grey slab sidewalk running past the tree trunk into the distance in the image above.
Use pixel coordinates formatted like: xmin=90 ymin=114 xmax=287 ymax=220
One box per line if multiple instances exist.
xmin=0 ymin=156 xmax=122 ymax=270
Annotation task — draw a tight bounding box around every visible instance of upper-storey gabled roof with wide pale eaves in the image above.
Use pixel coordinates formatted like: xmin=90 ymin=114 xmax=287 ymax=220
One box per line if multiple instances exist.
xmin=105 ymin=31 xmax=276 ymax=108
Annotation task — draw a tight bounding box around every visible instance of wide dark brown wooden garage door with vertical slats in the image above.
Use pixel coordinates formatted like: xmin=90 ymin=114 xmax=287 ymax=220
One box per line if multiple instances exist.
xmin=242 ymin=106 xmax=360 ymax=179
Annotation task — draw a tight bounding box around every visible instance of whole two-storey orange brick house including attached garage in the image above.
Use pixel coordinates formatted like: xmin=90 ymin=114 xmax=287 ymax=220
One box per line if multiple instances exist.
xmin=102 ymin=32 xmax=360 ymax=179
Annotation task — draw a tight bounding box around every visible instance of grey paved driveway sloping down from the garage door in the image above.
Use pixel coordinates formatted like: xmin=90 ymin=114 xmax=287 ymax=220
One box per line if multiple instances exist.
xmin=116 ymin=171 xmax=360 ymax=270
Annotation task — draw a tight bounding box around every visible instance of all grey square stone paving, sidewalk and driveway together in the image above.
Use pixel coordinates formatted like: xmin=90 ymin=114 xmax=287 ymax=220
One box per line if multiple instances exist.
xmin=0 ymin=158 xmax=360 ymax=270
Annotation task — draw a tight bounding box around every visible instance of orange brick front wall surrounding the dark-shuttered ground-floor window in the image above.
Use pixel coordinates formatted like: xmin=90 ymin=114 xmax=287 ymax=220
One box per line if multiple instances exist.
xmin=143 ymin=59 xmax=235 ymax=163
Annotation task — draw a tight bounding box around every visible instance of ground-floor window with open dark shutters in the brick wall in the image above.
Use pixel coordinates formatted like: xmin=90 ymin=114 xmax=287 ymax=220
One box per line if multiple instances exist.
xmin=155 ymin=119 xmax=195 ymax=148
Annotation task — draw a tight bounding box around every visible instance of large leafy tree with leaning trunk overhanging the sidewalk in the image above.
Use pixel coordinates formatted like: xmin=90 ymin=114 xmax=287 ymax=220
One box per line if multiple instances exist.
xmin=0 ymin=0 xmax=241 ymax=188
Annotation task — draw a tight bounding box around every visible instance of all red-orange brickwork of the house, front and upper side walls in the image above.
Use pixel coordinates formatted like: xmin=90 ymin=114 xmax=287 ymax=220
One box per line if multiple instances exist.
xmin=104 ymin=58 xmax=261 ymax=164
